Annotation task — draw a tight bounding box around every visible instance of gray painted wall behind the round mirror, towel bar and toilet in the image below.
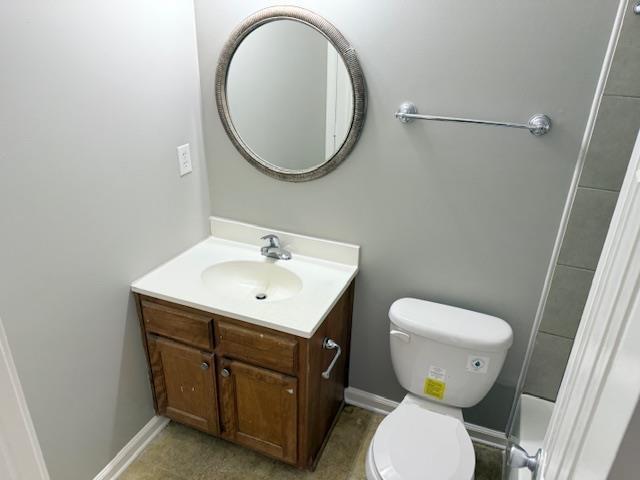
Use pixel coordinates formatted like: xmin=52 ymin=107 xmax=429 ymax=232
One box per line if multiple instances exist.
xmin=196 ymin=0 xmax=617 ymax=428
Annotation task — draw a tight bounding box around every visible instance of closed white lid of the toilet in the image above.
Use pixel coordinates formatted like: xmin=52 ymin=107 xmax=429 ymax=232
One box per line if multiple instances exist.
xmin=372 ymin=404 xmax=476 ymax=480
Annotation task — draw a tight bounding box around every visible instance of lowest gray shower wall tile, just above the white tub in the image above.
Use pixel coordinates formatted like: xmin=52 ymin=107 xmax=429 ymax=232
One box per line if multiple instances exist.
xmin=524 ymin=332 xmax=573 ymax=402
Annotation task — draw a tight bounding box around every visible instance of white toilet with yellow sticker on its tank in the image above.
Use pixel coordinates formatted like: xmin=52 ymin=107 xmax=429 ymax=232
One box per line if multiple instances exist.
xmin=366 ymin=298 xmax=513 ymax=480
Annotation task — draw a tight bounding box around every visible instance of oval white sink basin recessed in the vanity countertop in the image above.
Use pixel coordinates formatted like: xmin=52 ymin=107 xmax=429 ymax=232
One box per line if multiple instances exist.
xmin=202 ymin=260 xmax=302 ymax=302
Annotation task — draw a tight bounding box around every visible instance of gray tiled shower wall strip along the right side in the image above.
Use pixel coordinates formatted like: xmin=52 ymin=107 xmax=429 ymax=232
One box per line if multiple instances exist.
xmin=525 ymin=0 xmax=640 ymax=401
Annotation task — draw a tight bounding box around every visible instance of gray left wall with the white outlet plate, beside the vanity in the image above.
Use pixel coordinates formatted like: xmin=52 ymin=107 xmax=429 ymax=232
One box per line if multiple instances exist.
xmin=0 ymin=0 xmax=208 ymax=480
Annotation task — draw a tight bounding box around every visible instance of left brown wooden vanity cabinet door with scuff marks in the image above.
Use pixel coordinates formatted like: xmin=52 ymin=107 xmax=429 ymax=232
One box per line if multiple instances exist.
xmin=147 ymin=335 xmax=219 ymax=433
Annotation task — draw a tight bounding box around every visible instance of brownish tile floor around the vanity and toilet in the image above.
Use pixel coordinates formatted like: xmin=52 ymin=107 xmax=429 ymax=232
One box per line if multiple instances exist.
xmin=120 ymin=406 xmax=502 ymax=480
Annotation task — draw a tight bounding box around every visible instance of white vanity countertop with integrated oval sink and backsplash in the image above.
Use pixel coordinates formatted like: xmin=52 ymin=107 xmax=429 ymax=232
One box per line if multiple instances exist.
xmin=131 ymin=217 xmax=359 ymax=338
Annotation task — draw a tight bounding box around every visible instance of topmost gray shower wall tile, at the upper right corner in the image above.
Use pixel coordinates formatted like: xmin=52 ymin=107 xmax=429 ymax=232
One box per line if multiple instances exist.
xmin=605 ymin=0 xmax=640 ymax=97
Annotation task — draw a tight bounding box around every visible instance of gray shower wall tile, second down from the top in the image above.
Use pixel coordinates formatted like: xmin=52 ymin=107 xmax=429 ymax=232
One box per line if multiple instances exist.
xmin=580 ymin=94 xmax=640 ymax=190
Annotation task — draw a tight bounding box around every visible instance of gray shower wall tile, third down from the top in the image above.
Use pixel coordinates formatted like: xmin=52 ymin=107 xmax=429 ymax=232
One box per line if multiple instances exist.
xmin=558 ymin=187 xmax=618 ymax=270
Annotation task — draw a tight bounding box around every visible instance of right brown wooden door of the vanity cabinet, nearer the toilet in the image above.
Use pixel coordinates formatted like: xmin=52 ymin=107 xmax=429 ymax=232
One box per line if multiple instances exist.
xmin=218 ymin=358 xmax=298 ymax=463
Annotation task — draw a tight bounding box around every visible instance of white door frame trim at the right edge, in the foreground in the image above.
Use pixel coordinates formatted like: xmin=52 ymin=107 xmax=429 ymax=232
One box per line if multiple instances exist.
xmin=542 ymin=127 xmax=640 ymax=480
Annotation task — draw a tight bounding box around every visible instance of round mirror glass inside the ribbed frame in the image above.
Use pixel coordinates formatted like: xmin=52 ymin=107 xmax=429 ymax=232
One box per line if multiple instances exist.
xmin=226 ymin=19 xmax=354 ymax=171
